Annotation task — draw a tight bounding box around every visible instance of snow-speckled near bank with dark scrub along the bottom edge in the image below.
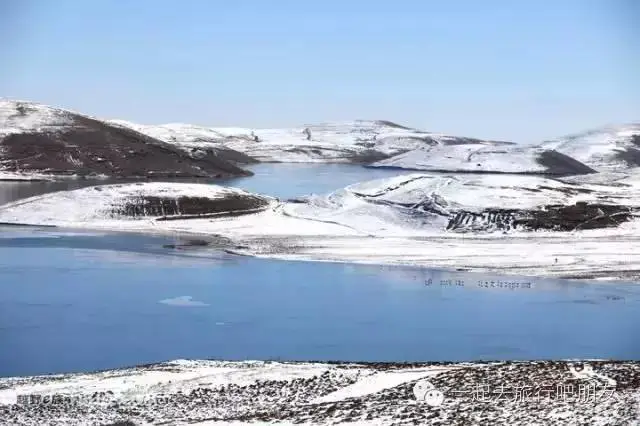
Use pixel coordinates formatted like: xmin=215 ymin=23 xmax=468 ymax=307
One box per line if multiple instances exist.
xmin=0 ymin=360 xmax=640 ymax=426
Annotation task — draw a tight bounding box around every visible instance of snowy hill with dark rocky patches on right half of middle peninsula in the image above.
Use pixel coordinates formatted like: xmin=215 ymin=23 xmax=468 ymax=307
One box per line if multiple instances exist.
xmin=283 ymin=174 xmax=640 ymax=236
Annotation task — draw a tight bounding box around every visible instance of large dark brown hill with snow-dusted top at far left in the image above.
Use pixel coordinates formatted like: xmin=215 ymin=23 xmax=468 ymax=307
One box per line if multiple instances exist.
xmin=0 ymin=99 xmax=251 ymax=178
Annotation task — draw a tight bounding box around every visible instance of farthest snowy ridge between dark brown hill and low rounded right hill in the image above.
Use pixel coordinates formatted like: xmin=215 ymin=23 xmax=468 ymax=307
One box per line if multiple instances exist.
xmin=113 ymin=120 xmax=510 ymax=164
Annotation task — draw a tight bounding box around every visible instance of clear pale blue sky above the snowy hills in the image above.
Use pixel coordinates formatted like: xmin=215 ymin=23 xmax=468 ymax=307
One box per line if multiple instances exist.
xmin=0 ymin=0 xmax=640 ymax=142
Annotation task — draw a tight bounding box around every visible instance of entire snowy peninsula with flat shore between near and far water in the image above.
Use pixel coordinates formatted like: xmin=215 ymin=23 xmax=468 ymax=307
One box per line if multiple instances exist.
xmin=0 ymin=174 xmax=640 ymax=279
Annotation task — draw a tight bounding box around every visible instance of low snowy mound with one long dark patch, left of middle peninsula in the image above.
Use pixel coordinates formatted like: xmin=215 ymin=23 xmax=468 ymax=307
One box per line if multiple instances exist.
xmin=0 ymin=182 xmax=275 ymax=229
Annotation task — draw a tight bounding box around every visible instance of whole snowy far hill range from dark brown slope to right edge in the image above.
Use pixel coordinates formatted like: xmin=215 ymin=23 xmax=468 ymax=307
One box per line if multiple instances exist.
xmin=113 ymin=116 xmax=640 ymax=176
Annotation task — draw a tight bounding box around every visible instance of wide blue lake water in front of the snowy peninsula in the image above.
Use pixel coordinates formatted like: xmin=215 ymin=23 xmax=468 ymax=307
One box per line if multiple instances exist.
xmin=0 ymin=229 xmax=640 ymax=376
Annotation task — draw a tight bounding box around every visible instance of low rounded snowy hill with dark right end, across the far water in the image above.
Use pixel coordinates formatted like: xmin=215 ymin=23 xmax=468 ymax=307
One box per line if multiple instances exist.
xmin=371 ymin=144 xmax=595 ymax=176
